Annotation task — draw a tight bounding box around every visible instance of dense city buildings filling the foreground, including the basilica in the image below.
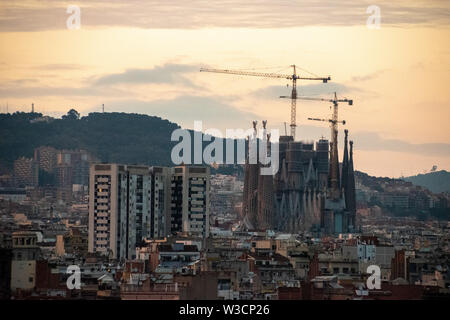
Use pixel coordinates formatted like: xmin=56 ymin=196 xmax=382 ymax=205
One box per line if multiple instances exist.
xmin=0 ymin=113 xmax=450 ymax=300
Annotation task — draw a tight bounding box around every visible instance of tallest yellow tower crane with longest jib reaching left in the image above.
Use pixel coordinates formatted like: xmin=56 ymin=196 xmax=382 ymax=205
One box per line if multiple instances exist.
xmin=200 ymin=64 xmax=331 ymax=140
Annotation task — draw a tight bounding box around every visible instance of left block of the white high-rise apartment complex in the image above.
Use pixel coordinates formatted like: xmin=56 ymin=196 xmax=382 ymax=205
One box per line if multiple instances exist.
xmin=89 ymin=164 xmax=153 ymax=259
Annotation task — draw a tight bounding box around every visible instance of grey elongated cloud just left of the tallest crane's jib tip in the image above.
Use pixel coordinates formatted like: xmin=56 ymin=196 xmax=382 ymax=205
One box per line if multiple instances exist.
xmin=94 ymin=64 xmax=199 ymax=87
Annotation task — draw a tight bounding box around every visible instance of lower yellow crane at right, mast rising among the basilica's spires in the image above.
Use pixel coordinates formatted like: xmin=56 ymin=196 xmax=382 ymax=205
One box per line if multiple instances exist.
xmin=280 ymin=92 xmax=353 ymax=198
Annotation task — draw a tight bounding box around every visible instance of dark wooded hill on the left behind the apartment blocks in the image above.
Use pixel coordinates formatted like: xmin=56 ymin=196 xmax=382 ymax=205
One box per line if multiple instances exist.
xmin=0 ymin=109 xmax=241 ymax=174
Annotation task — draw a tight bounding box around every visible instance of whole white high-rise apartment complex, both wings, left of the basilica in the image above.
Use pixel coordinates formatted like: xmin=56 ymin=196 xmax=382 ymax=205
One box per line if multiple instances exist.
xmin=89 ymin=164 xmax=209 ymax=259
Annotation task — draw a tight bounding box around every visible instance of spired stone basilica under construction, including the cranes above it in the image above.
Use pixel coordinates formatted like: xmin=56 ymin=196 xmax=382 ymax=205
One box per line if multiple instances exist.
xmin=200 ymin=65 xmax=357 ymax=236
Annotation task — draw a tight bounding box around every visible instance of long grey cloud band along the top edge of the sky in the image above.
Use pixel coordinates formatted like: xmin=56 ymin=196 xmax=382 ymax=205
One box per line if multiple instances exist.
xmin=0 ymin=0 xmax=450 ymax=31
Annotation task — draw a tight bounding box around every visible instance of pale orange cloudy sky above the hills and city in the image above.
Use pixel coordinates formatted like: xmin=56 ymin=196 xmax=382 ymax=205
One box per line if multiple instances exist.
xmin=0 ymin=0 xmax=450 ymax=177
